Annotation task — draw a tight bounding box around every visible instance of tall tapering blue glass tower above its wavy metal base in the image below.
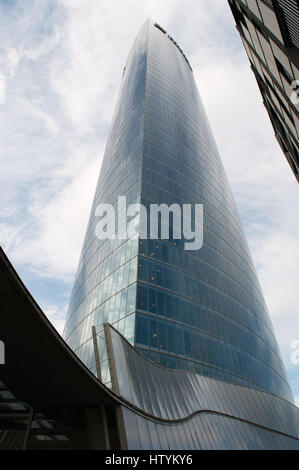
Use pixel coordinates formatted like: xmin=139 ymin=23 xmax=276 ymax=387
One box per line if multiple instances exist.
xmin=64 ymin=20 xmax=293 ymax=401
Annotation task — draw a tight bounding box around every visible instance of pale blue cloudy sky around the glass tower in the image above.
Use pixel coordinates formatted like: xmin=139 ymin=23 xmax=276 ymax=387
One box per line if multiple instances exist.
xmin=0 ymin=0 xmax=299 ymax=406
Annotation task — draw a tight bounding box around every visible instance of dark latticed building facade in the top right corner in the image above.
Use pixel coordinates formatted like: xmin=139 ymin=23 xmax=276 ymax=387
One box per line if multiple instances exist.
xmin=229 ymin=0 xmax=299 ymax=182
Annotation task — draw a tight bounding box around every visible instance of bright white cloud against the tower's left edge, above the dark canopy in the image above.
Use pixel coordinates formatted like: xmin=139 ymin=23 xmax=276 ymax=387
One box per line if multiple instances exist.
xmin=3 ymin=140 xmax=99 ymax=281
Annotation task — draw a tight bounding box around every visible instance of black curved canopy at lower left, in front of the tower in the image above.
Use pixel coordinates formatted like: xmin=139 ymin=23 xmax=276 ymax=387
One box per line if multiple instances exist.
xmin=0 ymin=248 xmax=116 ymax=407
